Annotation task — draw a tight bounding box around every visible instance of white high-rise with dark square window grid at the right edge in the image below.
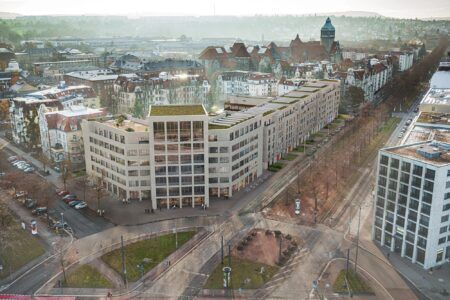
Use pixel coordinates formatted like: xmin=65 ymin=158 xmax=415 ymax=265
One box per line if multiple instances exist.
xmin=372 ymin=140 xmax=450 ymax=269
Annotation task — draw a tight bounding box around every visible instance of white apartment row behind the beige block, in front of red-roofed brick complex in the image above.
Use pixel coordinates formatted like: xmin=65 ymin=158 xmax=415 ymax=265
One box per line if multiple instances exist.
xmin=217 ymin=71 xmax=277 ymax=97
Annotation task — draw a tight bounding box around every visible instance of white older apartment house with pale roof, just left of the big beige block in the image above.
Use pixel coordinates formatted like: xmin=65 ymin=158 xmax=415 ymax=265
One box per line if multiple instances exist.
xmin=38 ymin=105 xmax=105 ymax=166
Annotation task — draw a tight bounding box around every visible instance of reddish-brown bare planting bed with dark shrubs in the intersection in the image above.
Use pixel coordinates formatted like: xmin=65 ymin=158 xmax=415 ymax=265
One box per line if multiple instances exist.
xmin=233 ymin=229 xmax=298 ymax=266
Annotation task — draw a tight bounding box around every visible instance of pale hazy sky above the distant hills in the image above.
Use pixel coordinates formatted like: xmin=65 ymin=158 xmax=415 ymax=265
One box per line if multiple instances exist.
xmin=0 ymin=0 xmax=450 ymax=18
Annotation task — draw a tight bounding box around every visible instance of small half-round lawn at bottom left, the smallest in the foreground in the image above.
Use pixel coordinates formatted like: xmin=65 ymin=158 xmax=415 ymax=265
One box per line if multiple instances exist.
xmin=64 ymin=265 xmax=113 ymax=288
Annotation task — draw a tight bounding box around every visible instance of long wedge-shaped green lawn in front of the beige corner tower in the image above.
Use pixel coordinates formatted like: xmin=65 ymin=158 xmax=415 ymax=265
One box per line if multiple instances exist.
xmin=101 ymin=231 xmax=196 ymax=281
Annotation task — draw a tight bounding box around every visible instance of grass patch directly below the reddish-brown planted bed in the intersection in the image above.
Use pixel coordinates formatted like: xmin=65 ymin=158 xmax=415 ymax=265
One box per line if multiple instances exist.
xmin=204 ymin=256 xmax=279 ymax=289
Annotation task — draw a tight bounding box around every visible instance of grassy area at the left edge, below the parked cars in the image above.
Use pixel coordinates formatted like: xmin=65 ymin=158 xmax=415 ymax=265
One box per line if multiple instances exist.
xmin=0 ymin=221 xmax=45 ymax=279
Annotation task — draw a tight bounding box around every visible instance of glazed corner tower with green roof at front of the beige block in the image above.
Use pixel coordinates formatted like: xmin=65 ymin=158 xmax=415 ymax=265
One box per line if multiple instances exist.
xmin=148 ymin=105 xmax=209 ymax=208
